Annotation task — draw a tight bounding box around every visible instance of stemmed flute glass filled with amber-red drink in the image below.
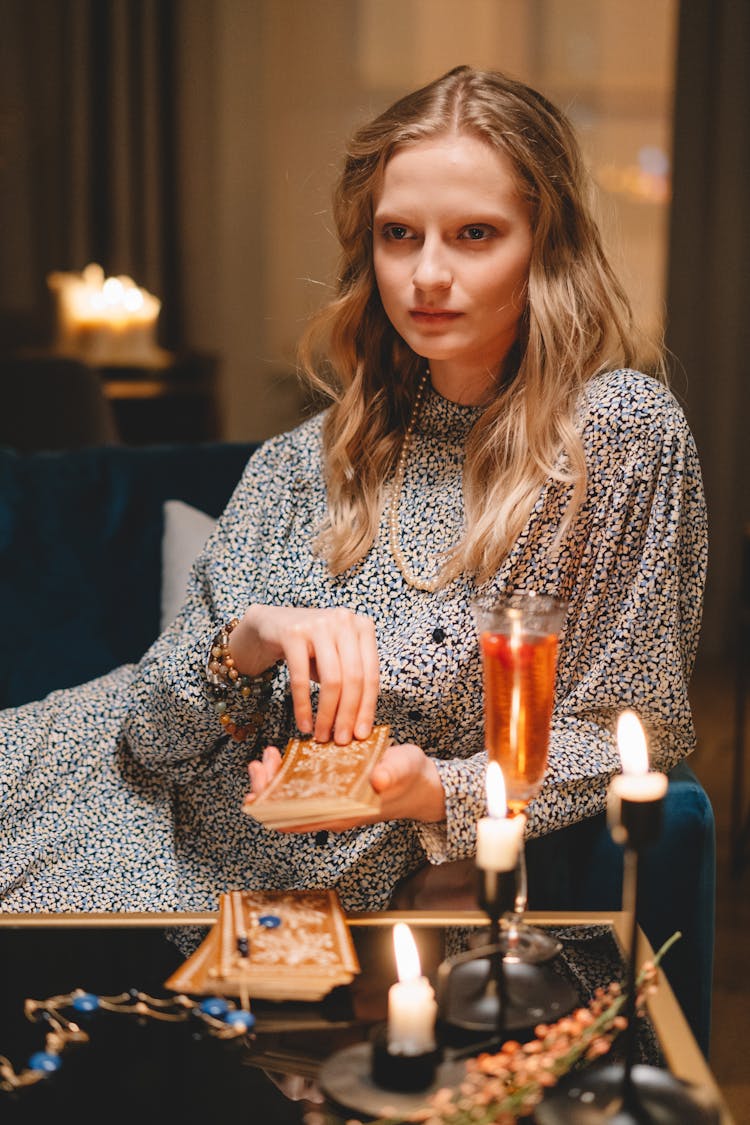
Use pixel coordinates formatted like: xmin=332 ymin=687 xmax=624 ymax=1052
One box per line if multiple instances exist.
xmin=473 ymin=591 xmax=567 ymax=962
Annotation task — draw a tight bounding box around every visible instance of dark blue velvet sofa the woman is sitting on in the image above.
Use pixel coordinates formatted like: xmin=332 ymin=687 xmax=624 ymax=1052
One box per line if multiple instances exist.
xmin=0 ymin=443 xmax=715 ymax=1051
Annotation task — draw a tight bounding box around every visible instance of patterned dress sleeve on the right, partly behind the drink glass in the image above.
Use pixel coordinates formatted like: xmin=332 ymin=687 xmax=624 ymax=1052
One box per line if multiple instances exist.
xmin=418 ymin=371 xmax=707 ymax=863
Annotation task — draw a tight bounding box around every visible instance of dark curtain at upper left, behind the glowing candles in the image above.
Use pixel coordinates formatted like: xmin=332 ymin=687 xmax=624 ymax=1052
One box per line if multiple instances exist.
xmin=0 ymin=0 xmax=182 ymax=348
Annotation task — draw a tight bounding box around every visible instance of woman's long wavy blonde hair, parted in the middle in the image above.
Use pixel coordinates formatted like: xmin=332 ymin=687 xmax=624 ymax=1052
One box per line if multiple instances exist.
xmin=299 ymin=66 xmax=662 ymax=584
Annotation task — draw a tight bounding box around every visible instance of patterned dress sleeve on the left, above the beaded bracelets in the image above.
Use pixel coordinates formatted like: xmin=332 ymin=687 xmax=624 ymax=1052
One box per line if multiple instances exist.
xmin=124 ymin=425 xmax=310 ymax=783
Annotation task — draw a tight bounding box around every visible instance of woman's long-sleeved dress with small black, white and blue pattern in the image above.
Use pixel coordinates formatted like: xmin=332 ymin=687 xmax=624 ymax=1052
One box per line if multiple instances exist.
xmin=0 ymin=371 xmax=706 ymax=910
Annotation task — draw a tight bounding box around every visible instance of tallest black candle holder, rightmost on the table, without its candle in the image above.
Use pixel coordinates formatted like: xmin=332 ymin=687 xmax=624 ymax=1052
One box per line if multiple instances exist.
xmin=534 ymin=795 xmax=720 ymax=1125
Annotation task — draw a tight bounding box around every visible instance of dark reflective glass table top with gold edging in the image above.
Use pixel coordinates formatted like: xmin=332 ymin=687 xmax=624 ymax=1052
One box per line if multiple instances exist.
xmin=0 ymin=911 xmax=729 ymax=1125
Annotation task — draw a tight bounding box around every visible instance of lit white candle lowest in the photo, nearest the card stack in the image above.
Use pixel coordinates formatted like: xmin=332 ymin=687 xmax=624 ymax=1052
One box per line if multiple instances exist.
xmin=388 ymin=921 xmax=437 ymax=1055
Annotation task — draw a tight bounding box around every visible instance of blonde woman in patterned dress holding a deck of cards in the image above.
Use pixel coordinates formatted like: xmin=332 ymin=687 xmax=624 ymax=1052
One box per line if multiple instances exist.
xmin=0 ymin=68 xmax=705 ymax=909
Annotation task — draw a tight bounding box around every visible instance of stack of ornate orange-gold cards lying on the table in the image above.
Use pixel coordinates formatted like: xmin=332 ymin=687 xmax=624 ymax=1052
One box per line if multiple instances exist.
xmin=165 ymin=890 xmax=360 ymax=1001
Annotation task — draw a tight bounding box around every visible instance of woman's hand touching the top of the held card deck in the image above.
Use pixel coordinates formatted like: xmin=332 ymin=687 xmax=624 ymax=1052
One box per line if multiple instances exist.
xmin=229 ymin=605 xmax=380 ymax=745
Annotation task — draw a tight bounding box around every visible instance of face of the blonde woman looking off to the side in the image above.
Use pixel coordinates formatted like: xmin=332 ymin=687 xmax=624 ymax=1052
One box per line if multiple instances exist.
xmin=372 ymin=134 xmax=532 ymax=403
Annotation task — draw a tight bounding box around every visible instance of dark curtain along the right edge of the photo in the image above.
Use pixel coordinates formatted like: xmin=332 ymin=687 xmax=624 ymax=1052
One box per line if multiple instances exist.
xmin=667 ymin=0 xmax=750 ymax=658
